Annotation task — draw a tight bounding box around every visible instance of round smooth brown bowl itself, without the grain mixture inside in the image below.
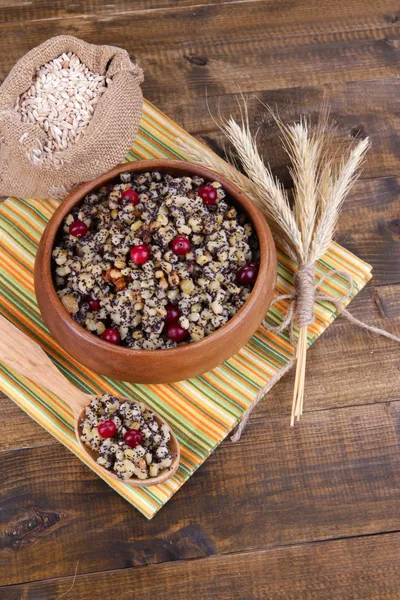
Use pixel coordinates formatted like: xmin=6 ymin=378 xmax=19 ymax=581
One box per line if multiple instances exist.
xmin=35 ymin=160 xmax=277 ymax=383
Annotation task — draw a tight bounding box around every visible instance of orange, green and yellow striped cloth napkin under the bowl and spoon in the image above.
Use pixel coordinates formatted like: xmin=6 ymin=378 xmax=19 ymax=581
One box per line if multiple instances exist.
xmin=0 ymin=102 xmax=371 ymax=519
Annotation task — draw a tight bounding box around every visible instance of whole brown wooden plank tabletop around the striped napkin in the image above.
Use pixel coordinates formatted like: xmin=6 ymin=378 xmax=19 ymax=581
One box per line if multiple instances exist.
xmin=0 ymin=0 xmax=400 ymax=600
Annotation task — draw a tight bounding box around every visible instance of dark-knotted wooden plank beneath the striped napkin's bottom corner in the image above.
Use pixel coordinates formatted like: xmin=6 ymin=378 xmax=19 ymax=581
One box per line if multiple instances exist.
xmin=0 ymin=398 xmax=400 ymax=584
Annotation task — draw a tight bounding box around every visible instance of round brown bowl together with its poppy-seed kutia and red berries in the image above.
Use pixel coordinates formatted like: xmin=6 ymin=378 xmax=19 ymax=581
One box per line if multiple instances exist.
xmin=35 ymin=160 xmax=276 ymax=383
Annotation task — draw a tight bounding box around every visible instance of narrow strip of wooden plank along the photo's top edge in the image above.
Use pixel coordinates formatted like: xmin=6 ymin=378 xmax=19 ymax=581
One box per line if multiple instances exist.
xmin=0 ymin=0 xmax=398 ymax=27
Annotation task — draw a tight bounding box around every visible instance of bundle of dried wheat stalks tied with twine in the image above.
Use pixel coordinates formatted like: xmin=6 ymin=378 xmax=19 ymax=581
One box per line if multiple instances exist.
xmin=179 ymin=105 xmax=369 ymax=425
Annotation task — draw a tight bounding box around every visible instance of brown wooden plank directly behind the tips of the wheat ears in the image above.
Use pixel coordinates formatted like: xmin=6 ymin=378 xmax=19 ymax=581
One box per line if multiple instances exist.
xmin=165 ymin=78 xmax=400 ymax=183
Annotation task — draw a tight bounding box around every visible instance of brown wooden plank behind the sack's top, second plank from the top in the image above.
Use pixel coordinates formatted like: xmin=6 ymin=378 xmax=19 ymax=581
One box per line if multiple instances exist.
xmin=0 ymin=0 xmax=400 ymax=104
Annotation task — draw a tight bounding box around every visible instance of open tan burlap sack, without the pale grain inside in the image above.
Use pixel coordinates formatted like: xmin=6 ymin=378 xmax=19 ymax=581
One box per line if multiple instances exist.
xmin=0 ymin=35 xmax=143 ymax=198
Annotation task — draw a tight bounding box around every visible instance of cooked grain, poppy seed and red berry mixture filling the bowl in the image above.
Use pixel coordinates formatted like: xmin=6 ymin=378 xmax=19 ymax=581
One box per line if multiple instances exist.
xmin=53 ymin=171 xmax=259 ymax=350
